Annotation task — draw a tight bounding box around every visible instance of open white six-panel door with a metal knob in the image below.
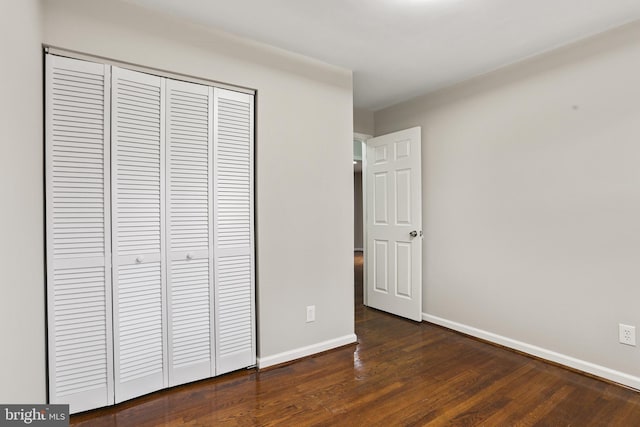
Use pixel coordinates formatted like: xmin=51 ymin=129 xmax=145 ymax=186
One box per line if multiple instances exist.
xmin=365 ymin=127 xmax=422 ymax=321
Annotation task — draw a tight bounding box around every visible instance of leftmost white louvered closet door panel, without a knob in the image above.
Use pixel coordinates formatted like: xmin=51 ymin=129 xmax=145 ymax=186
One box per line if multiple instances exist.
xmin=45 ymin=55 xmax=113 ymax=412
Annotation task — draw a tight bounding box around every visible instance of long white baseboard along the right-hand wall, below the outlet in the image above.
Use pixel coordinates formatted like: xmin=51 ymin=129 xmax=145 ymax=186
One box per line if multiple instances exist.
xmin=422 ymin=313 xmax=640 ymax=390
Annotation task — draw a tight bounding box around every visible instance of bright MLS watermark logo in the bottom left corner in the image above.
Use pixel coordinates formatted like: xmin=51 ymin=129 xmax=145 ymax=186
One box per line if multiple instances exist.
xmin=0 ymin=405 xmax=69 ymax=427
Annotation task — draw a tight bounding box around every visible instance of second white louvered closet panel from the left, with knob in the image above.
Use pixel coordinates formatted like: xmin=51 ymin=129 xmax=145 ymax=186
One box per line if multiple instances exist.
xmin=111 ymin=67 xmax=167 ymax=402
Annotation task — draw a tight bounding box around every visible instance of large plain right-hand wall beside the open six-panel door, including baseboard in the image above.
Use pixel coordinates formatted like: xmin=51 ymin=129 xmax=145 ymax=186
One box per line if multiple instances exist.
xmin=375 ymin=23 xmax=640 ymax=388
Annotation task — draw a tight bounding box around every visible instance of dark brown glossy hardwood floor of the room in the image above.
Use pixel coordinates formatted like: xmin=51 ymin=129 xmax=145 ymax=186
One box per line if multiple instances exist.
xmin=71 ymin=252 xmax=640 ymax=427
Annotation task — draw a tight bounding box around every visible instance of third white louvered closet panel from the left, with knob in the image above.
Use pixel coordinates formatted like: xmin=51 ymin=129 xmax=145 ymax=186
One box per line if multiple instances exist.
xmin=166 ymin=80 xmax=215 ymax=386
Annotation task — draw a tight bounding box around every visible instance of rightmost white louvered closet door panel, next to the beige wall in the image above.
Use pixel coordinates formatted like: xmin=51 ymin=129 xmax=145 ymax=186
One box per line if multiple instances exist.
xmin=214 ymin=88 xmax=256 ymax=374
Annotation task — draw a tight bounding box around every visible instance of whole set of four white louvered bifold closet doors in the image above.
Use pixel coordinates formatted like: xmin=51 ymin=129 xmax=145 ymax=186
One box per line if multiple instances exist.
xmin=45 ymin=55 xmax=256 ymax=413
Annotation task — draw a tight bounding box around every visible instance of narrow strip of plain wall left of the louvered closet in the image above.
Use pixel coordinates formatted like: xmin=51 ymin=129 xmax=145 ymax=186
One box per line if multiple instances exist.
xmin=0 ymin=0 xmax=46 ymax=403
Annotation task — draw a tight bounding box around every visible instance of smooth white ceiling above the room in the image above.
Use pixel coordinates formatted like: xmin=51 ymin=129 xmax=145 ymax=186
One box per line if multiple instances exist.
xmin=128 ymin=0 xmax=640 ymax=111
